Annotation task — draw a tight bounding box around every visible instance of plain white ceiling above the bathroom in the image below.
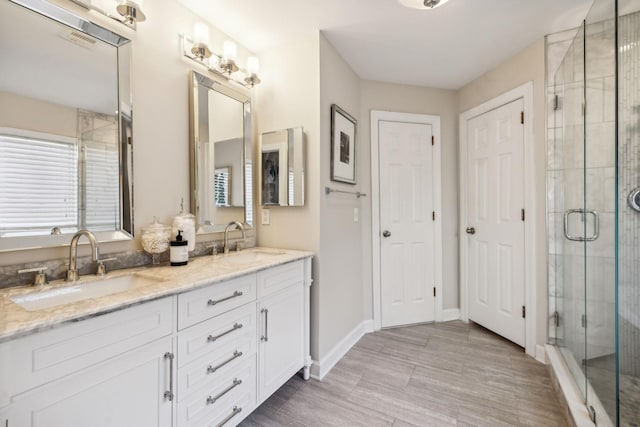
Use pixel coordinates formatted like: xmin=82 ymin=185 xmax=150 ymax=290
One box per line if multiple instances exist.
xmin=180 ymin=0 xmax=592 ymax=89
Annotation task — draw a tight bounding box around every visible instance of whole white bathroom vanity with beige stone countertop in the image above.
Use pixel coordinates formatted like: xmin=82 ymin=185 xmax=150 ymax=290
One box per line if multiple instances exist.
xmin=0 ymin=248 xmax=311 ymax=427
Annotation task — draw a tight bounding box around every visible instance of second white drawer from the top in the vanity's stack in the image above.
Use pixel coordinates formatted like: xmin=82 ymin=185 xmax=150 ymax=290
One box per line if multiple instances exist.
xmin=178 ymin=301 xmax=256 ymax=367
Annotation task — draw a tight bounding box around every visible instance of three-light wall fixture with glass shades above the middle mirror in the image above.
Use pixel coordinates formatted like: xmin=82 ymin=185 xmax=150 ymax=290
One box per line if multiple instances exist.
xmin=182 ymin=22 xmax=260 ymax=88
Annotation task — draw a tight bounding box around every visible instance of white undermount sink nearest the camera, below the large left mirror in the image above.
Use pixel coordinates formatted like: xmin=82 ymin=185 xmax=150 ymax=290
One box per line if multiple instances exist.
xmin=9 ymin=273 xmax=157 ymax=311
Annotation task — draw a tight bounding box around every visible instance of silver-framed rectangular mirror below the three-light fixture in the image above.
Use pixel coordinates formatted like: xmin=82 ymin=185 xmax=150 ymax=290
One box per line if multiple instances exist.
xmin=189 ymin=71 xmax=253 ymax=234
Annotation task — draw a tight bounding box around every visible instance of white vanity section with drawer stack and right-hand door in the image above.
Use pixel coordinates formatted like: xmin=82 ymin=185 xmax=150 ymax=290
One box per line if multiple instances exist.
xmin=176 ymin=259 xmax=311 ymax=427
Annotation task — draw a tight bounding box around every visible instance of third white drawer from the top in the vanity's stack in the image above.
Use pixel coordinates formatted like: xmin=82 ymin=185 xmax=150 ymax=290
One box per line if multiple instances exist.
xmin=176 ymin=334 xmax=256 ymax=401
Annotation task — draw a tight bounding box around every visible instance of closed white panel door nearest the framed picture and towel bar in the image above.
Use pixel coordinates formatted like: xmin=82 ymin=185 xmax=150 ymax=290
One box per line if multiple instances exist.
xmin=378 ymin=121 xmax=435 ymax=327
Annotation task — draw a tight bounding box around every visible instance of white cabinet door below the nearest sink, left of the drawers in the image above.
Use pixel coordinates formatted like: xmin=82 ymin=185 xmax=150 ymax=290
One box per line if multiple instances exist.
xmin=7 ymin=337 xmax=175 ymax=427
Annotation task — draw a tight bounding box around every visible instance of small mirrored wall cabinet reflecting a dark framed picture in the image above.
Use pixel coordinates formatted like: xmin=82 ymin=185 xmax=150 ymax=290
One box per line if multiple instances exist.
xmin=260 ymin=127 xmax=305 ymax=206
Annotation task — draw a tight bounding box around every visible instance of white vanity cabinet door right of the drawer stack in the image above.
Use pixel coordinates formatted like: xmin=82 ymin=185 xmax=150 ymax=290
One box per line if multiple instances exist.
xmin=258 ymin=284 xmax=304 ymax=403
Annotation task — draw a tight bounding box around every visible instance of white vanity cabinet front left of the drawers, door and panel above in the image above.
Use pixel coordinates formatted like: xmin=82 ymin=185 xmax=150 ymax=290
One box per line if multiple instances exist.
xmin=0 ymin=297 xmax=175 ymax=427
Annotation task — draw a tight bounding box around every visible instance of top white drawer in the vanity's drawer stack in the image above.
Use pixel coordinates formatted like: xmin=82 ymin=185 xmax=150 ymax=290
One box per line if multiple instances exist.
xmin=178 ymin=274 xmax=256 ymax=330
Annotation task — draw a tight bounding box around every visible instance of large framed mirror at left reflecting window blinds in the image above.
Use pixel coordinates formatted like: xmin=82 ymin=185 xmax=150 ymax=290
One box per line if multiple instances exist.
xmin=0 ymin=0 xmax=133 ymax=251
